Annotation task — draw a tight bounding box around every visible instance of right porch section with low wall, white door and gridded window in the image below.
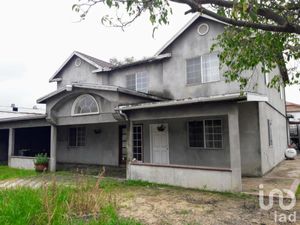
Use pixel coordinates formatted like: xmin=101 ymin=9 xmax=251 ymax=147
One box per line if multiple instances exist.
xmin=123 ymin=102 xmax=242 ymax=191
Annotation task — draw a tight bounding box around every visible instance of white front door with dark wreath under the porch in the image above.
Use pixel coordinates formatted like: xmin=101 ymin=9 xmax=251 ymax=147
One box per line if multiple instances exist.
xmin=150 ymin=123 xmax=169 ymax=164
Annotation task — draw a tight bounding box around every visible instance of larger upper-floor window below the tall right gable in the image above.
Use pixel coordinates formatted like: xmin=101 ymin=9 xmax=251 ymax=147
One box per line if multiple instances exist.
xmin=186 ymin=52 xmax=220 ymax=84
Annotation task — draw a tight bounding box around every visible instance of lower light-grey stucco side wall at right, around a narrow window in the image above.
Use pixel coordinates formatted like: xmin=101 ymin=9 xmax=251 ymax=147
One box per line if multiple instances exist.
xmin=259 ymin=102 xmax=287 ymax=174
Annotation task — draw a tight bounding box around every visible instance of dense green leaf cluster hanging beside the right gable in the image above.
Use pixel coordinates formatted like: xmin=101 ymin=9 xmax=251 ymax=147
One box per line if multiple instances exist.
xmin=211 ymin=26 xmax=300 ymax=90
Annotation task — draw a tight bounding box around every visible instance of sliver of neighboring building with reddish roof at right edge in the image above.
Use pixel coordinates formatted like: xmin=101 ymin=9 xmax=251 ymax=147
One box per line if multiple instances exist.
xmin=286 ymin=102 xmax=300 ymax=150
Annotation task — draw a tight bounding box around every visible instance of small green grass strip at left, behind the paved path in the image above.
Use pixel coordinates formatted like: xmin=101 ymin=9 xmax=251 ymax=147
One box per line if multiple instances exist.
xmin=0 ymin=166 xmax=38 ymax=180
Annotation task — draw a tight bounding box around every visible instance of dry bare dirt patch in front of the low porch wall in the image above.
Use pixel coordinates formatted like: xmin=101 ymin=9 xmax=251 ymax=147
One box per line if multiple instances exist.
xmin=118 ymin=187 xmax=300 ymax=225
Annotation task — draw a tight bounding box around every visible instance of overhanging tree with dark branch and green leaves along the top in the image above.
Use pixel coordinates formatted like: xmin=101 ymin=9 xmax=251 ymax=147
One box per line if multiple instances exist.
xmin=73 ymin=0 xmax=300 ymax=89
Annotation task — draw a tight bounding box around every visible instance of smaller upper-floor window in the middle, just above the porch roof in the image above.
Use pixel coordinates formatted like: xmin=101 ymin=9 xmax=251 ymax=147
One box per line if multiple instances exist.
xmin=126 ymin=72 xmax=149 ymax=93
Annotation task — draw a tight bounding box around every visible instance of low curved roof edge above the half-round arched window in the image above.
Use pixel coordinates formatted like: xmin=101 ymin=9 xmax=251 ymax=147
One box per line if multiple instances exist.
xmin=37 ymin=83 xmax=166 ymax=103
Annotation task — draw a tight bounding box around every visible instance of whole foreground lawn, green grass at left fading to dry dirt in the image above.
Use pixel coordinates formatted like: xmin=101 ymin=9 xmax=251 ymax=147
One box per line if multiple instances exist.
xmin=0 ymin=169 xmax=300 ymax=225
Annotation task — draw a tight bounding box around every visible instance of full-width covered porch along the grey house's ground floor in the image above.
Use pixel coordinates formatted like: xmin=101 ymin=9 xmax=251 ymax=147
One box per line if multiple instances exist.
xmin=0 ymin=99 xmax=242 ymax=191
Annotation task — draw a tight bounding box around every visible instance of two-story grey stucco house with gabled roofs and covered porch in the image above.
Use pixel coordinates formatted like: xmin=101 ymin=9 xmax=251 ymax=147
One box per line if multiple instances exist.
xmin=0 ymin=13 xmax=287 ymax=191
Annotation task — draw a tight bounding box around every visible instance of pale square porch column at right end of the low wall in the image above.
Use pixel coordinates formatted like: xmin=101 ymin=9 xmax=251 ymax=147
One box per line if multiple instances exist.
xmin=228 ymin=106 xmax=242 ymax=191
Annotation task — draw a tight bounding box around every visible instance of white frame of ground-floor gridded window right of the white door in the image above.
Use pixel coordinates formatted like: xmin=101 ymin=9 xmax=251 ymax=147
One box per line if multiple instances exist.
xmin=187 ymin=118 xmax=224 ymax=150
